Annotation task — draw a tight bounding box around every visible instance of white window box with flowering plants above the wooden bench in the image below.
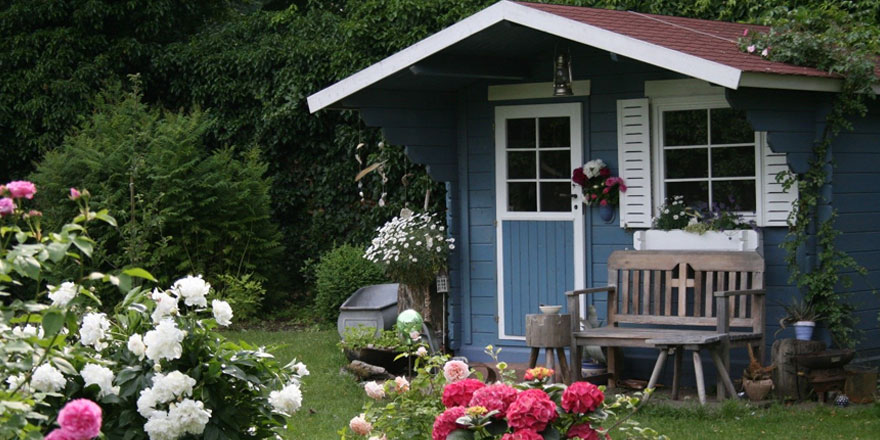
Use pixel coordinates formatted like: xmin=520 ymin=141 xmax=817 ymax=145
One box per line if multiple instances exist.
xmin=633 ymin=196 xmax=763 ymax=252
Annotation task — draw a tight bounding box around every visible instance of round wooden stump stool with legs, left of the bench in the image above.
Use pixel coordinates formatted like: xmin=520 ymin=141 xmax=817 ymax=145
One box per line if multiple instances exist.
xmin=526 ymin=314 xmax=579 ymax=383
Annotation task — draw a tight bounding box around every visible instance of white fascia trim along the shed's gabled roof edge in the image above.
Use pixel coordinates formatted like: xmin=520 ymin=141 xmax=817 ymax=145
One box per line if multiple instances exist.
xmin=308 ymin=0 xmax=840 ymax=113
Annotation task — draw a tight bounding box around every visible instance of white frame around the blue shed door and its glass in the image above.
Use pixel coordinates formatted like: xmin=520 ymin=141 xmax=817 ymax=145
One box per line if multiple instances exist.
xmin=495 ymin=102 xmax=586 ymax=340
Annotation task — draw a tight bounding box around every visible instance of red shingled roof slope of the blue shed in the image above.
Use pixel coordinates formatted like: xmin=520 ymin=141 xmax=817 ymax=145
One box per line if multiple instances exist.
xmin=518 ymin=2 xmax=836 ymax=78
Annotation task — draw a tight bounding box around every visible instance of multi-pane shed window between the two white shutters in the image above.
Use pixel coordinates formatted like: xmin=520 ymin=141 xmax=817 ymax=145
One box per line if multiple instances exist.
xmin=654 ymin=97 xmax=761 ymax=217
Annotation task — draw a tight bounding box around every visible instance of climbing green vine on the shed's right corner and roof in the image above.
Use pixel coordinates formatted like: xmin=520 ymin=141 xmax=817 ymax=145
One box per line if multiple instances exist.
xmin=740 ymin=2 xmax=880 ymax=347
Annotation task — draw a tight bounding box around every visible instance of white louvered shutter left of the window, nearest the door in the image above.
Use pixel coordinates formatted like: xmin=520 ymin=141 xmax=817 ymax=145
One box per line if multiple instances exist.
xmin=617 ymin=98 xmax=653 ymax=228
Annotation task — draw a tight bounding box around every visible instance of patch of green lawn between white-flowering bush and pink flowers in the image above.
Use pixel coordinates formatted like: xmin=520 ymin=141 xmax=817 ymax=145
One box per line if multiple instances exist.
xmin=224 ymin=329 xmax=370 ymax=440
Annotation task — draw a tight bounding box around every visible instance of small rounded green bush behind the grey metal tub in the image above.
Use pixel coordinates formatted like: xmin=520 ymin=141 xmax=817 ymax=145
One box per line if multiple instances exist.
xmin=315 ymin=244 xmax=386 ymax=321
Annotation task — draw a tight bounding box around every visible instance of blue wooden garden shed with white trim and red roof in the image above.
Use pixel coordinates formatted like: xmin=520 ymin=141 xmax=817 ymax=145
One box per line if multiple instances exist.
xmin=308 ymin=1 xmax=880 ymax=376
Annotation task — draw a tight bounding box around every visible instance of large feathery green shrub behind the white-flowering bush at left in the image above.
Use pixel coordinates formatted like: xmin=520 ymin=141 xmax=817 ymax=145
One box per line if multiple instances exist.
xmin=33 ymin=81 xmax=282 ymax=305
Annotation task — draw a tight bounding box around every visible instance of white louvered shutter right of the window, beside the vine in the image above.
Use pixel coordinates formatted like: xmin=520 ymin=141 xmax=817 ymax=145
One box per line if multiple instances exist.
xmin=759 ymin=133 xmax=798 ymax=226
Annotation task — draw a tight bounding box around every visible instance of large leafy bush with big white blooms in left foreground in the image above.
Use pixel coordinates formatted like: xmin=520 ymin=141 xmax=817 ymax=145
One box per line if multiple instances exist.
xmin=0 ymin=184 xmax=309 ymax=440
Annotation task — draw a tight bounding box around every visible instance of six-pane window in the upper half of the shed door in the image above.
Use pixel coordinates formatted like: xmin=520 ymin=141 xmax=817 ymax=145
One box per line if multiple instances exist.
xmin=504 ymin=116 xmax=572 ymax=212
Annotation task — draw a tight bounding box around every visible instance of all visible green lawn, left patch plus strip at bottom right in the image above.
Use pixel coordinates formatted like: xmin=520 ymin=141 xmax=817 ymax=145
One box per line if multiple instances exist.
xmin=226 ymin=329 xmax=880 ymax=440
